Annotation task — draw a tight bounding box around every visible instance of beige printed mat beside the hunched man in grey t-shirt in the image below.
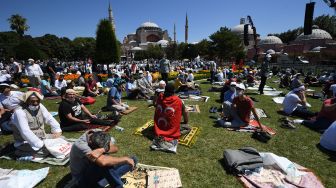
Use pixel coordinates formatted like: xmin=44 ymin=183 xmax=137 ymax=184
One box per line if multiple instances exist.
xmin=122 ymin=163 xmax=182 ymax=188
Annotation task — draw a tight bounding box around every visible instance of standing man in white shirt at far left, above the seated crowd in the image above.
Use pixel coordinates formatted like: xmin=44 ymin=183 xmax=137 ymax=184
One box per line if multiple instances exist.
xmin=25 ymin=59 xmax=43 ymax=87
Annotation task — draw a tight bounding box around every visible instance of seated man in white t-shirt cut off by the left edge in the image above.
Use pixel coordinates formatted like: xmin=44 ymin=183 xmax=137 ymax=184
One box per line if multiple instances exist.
xmin=0 ymin=84 xmax=23 ymax=134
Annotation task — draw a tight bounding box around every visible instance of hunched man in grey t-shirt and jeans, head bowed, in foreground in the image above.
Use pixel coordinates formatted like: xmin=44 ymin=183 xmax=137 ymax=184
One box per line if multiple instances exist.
xmin=70 ymin=129 xmax=137 ymax=187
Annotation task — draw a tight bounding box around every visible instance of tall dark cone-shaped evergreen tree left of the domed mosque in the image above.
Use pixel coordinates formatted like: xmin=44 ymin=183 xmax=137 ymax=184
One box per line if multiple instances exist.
xmin=96 ymin=19 xmax=120 ymax=64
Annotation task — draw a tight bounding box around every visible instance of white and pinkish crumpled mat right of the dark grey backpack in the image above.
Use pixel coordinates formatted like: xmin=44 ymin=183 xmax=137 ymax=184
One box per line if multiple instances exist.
xmin=238 ymin=153 xmax=324 ymax=188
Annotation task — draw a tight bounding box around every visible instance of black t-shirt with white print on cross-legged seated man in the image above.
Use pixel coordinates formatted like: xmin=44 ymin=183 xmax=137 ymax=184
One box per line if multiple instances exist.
xmin=58 ymin=99 xmax=82 ymax=126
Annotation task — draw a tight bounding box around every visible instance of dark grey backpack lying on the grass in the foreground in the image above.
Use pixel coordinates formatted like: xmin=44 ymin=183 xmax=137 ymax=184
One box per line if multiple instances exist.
xmin=224 ymin=147 xmax=264 ymax=175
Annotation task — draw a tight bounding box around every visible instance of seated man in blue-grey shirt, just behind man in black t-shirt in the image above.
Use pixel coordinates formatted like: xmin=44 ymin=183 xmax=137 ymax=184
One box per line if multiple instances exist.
xmin=106 ymin=81 xmax=129 ymax=112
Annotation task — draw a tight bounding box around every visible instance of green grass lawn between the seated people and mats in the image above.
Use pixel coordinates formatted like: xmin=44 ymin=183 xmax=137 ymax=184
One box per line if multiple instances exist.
xmin=0 ymin=77 xmax=336 ymax=187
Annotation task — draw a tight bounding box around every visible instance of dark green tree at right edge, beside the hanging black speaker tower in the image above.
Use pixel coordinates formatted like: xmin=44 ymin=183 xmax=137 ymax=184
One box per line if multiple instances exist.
xmin=313 ymin=15 xmax=336 ymax=39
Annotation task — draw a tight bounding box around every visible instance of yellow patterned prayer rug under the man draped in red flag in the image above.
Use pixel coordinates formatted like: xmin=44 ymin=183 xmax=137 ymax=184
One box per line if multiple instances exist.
xmin=134 ymin=120 xmax=200 ymax=147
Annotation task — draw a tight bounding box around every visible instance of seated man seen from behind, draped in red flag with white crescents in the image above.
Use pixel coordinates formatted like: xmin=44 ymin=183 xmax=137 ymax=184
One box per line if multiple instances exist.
xmin=150 ymin=84 xmax=188 ymax=153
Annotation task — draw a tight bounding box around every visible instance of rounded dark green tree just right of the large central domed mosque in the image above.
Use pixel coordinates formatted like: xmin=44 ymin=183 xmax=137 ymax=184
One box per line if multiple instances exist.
xmin=209 ymin=27 xmax=244 ymax=61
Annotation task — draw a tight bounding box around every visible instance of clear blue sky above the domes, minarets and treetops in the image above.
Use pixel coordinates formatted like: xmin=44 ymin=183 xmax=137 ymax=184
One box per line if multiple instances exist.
xmin=0 ymin=0 xmax=335 ymax=42
